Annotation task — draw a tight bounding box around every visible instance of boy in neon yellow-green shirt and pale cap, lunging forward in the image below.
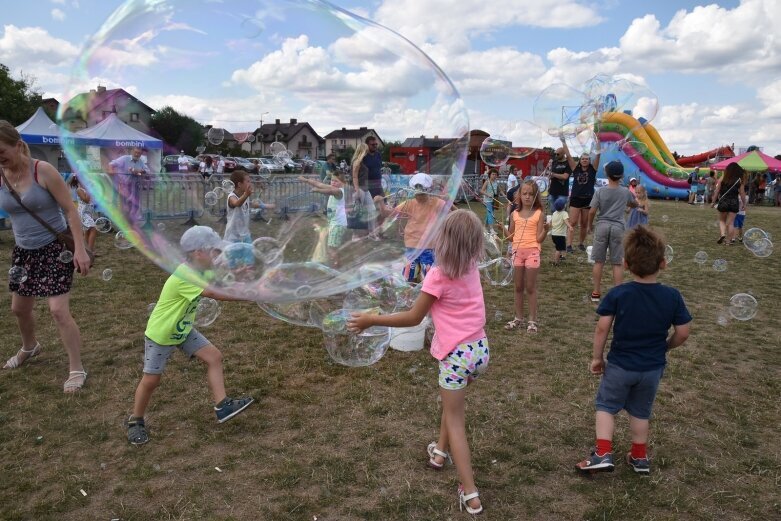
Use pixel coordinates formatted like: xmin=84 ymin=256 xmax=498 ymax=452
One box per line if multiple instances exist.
xmin=127 ymin=226 xmax=253 ymax=445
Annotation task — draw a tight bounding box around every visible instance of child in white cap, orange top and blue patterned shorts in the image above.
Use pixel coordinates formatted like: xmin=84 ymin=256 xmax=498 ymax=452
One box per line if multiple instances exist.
xmin=374 ymin=172 xmax=453 ymax=282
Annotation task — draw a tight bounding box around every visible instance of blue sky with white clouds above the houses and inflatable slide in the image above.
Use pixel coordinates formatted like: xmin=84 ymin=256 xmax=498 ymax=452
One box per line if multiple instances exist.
xmin=0 ymin=0 xmax=781 ymax=154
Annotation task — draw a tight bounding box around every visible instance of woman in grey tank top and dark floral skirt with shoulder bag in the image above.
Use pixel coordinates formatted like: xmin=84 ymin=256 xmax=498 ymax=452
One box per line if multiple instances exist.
xmin=0 ymin=120 xmax=90 ymax=393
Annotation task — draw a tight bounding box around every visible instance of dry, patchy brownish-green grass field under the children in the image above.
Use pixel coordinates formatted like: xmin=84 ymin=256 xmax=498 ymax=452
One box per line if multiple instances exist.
xmin=0 ymin=201 xmax=781 ymax=521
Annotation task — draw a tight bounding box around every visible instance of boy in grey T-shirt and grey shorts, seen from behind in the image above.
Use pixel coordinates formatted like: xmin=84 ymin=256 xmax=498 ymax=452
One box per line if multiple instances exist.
xmin=588 ymin=161 xmax=637 ymax=302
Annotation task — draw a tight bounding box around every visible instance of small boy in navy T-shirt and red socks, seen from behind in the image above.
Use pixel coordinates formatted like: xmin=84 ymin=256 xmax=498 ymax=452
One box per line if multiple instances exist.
xmin=575 ymin=225 xmax=691 ymax=474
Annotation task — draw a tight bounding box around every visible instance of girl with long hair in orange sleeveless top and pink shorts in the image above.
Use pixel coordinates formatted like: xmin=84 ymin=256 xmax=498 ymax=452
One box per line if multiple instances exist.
xmin=504 ymin=179 xmax=550 ymax=333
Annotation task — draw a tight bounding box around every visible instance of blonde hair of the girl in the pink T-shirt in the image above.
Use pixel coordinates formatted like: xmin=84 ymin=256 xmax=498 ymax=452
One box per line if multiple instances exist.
xmin=434 ymin=210 xmax=484 ymax=279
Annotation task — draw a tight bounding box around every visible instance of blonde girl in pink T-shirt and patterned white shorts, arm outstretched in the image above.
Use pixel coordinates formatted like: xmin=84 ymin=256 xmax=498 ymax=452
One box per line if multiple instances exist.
xmin=347 ymin=210 xmax=489 ymax=515
